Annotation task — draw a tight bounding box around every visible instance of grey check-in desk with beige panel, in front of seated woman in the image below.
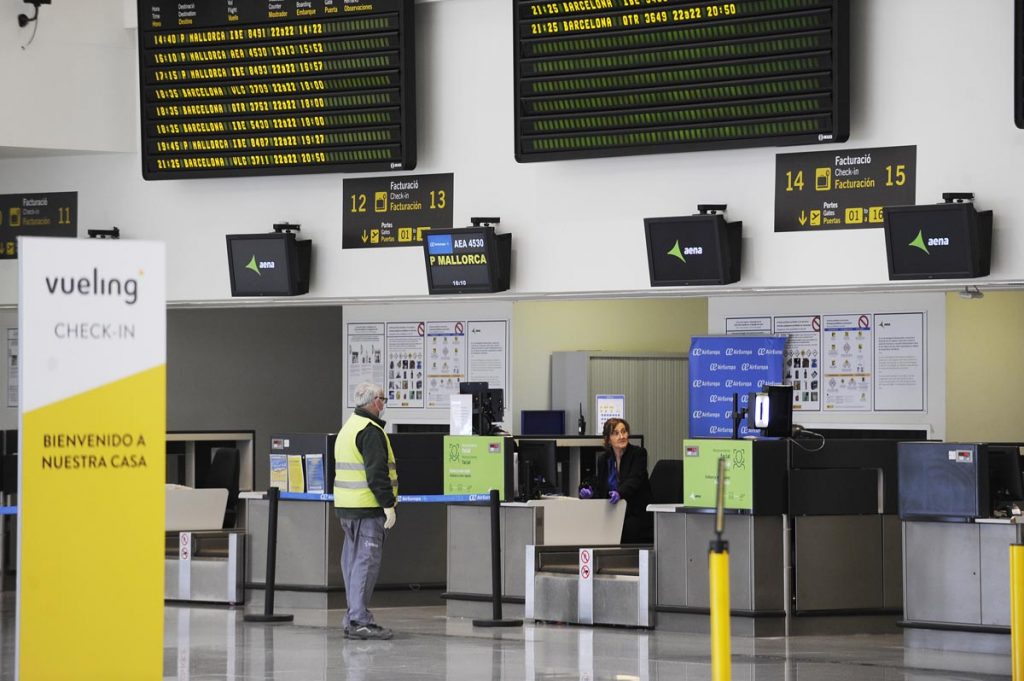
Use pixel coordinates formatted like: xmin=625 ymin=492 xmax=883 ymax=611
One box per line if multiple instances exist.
xmin=444 ymin=497 xmax=626 ymax=618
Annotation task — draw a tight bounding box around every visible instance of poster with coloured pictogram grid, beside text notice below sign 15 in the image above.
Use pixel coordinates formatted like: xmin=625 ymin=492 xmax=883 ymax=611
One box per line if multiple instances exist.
xmin=821 ymin=313 xmax=873 ymax=412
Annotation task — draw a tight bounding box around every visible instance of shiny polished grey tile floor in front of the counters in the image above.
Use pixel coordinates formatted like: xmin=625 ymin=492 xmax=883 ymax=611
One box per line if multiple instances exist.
xmin=0 ymin=592 xmax=1010 ymax=681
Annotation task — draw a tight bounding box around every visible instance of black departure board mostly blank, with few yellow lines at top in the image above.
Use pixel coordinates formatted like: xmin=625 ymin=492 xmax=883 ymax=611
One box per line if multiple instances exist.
xmin=515 ymin=0 xmax=850 ymax=162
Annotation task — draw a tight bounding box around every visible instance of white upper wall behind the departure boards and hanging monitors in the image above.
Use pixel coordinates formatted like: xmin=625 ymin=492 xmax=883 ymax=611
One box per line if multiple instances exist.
xmin=0 ymin=0 xmax=1024 ymax=305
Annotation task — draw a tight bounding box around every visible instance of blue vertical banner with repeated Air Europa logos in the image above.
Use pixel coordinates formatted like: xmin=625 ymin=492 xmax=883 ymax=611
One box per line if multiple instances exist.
xmin=689 ymin=336 xmax=785 ymax=438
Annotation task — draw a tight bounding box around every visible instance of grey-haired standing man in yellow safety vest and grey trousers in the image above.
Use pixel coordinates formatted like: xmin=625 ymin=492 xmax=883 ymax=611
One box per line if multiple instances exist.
xmin=334 ymin=383 xmax=398 ymax=640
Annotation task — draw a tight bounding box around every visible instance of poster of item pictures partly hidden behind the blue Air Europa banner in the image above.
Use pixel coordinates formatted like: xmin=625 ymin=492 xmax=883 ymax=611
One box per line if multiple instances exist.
xmin=774 ymin=314 xmax=821 ymax=412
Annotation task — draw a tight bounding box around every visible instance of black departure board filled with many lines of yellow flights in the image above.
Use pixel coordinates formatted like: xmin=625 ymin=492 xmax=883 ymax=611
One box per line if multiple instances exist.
xmin=138 ymin=0 xmax=416 ymax=180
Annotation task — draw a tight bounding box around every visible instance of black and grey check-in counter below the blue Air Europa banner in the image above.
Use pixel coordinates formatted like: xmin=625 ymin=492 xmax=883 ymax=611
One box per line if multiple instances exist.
xmin=650 ymin=439 xmax=901 ymax=636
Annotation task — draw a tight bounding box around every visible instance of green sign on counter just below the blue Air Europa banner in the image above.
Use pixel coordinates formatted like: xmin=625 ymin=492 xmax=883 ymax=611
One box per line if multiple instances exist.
xmin=683 ymin=439 xmax=754 ymax=511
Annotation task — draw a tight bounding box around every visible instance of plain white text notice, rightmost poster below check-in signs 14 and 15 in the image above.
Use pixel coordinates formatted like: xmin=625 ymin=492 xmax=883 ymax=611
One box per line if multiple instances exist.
xmin=874 ymin=312 xmax=926 ymax=412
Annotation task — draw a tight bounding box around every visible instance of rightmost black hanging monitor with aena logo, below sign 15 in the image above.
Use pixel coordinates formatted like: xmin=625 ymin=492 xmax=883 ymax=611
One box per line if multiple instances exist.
xmin=885 ymin=203 xmax=992 ymax=281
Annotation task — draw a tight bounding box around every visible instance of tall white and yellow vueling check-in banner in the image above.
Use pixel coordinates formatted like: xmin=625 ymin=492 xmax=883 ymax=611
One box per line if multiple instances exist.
xmin=16 ymin=238 xmax=167 ymax=681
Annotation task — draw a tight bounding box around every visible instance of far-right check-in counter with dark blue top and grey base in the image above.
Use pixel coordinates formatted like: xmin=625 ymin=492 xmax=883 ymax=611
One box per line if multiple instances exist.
xmin=899 ymin=442 xmax=1024 ymax=654
